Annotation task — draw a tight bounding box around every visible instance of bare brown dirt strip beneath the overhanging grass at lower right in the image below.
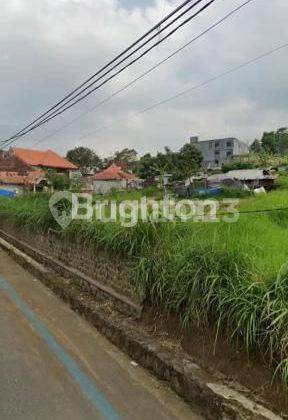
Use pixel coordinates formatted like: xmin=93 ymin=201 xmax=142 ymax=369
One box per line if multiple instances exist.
xmin=141 ymin=308 xmax=288 ymax=418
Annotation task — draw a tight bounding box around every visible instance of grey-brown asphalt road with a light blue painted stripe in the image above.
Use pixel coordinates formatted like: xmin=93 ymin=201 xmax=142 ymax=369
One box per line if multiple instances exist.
xmin=0 ymin=251 xmax=201 ymax=420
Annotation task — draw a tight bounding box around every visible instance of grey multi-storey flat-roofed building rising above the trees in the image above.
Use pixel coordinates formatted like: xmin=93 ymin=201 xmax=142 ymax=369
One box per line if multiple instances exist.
xmin=190 ymin=137 xmax=249 ymax=169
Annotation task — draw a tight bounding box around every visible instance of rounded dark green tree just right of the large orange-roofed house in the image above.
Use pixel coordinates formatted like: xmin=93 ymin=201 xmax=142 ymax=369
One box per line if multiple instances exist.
xmin=67 ymin=146 xmax=101 ymax=176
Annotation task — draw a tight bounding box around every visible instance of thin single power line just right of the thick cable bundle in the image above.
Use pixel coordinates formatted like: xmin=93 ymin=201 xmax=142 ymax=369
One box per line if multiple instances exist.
xmin=33 ymin=0 xmax=254 ymax=146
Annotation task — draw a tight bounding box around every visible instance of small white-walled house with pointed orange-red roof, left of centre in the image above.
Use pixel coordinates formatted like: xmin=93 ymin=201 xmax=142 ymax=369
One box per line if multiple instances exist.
xmin=92 ymin=164 xmax=140 ymax=194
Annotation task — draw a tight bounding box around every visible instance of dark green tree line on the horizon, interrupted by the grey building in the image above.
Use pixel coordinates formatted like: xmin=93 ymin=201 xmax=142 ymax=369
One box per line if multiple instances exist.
xmin=67 ymin=127 xmax=288 ymax=180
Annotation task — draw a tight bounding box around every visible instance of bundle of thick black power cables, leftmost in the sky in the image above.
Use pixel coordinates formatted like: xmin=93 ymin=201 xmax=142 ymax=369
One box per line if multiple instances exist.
xmin=2 ymin=0 xmax=215 ymax=143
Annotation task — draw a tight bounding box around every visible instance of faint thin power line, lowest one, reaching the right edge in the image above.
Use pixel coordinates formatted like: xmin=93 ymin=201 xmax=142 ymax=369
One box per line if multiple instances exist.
xmin=79 ymin=42 xmax=288 ymax=140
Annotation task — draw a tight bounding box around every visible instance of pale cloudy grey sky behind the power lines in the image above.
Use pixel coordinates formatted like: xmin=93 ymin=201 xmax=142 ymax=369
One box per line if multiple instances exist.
xmin=0 ymin=0 xmax=288 ymax=157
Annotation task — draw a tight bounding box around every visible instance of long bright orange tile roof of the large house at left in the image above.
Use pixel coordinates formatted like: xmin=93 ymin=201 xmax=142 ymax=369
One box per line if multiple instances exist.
xmin=12 ymin=147 xmax=77 ymax=169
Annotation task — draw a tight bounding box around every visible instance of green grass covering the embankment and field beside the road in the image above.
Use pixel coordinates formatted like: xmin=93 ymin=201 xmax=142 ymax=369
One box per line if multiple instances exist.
xmin=0 ymin=184 xmax=288 ymax=384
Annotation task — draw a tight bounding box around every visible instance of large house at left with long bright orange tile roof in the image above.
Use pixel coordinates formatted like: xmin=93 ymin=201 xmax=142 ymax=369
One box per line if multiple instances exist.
xmin=10 ymin=147 xmax=78 ymax=178
